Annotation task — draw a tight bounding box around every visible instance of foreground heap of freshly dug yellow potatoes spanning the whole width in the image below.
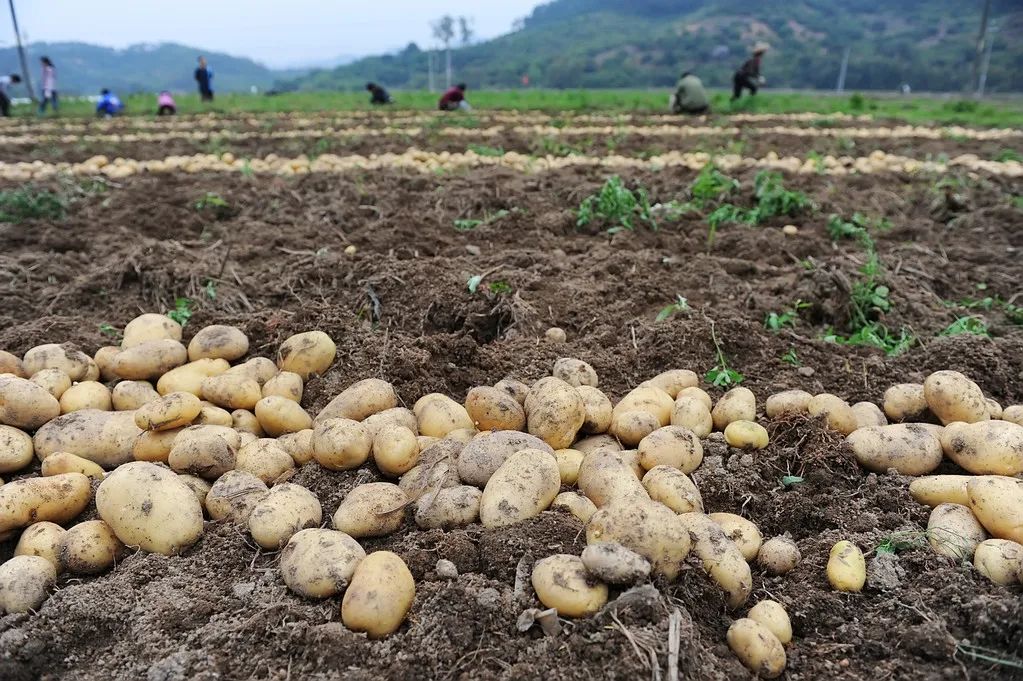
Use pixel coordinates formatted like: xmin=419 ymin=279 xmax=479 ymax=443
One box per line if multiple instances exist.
xmin=0 ymin=314 xmax=1023 ymax=678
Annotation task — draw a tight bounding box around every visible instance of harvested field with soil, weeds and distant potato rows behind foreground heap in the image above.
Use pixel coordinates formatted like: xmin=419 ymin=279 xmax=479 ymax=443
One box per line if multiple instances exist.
xmin=0 ymin=95 xmax=1023 ymax=681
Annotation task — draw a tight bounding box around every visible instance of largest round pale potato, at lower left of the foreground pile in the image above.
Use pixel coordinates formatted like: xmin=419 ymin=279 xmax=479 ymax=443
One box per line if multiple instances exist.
xmin=96 ymin=461 xmax=203 ymax=555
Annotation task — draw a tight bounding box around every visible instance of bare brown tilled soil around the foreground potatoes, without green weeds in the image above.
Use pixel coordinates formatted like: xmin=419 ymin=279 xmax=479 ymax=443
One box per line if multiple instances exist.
xmin=0 ymin=112 xmax=1023 ymax=681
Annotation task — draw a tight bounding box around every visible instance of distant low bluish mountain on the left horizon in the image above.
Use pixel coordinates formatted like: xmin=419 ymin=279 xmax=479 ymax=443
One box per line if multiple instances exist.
xmin=0 ymin=43 xmax=286 ymax=95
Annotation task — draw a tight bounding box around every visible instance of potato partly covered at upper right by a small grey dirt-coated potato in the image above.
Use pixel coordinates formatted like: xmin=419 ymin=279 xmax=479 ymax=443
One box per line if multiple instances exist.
xmin=531 ymin=553 xmax=608 ymax=618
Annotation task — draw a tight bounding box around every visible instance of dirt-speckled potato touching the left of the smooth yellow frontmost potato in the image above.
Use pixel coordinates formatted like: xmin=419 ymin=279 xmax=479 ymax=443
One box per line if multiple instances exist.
xmin=280 ymin=528 xmax=366 ymax=598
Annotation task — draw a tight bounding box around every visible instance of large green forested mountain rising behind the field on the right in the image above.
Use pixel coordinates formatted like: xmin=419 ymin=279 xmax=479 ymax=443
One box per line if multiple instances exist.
xmin=278 ymin=0 xmax=1023 ymax=92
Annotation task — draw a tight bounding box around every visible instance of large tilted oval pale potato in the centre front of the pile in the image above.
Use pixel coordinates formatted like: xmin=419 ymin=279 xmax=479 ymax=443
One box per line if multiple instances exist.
xmin=480 ymin=449 xmax=562 ymax=529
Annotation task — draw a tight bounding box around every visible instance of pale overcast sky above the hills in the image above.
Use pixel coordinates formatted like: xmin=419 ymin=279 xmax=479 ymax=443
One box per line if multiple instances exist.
xmin=0 ymin=0 xmax=541 ymax=66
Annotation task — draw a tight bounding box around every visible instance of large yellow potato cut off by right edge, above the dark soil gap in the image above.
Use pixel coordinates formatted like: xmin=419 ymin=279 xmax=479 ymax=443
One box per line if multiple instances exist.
xmin=941 ymin=421 xmax=1023 ymax=475
